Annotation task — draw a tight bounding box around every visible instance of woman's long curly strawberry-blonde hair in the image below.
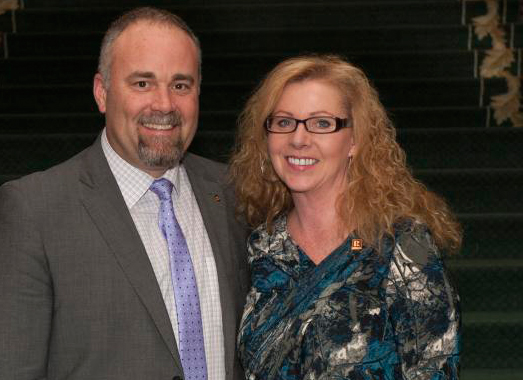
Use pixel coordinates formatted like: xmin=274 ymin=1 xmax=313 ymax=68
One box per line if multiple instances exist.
xmin=230 ymin=55 xmax=461 ymax=252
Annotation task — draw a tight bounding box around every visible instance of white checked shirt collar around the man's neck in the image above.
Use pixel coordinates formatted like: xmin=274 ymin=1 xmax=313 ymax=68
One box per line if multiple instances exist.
xmin=101 ymin=128 xmax=181 ymax=209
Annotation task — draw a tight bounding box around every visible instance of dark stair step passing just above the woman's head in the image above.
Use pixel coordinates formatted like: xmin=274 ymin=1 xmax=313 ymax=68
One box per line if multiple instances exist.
xmin=0 ymin=25 xmax=482 ymax=57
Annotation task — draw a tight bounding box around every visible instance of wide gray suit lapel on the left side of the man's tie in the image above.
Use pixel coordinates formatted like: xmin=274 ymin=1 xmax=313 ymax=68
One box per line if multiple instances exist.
xmin=80 ymin=138 xmax=182 ymax=370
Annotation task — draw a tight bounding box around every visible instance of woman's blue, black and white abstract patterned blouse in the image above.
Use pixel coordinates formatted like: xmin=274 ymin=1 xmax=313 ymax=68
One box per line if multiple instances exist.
xmin=238 ymin=216 xmax=460 ymax=380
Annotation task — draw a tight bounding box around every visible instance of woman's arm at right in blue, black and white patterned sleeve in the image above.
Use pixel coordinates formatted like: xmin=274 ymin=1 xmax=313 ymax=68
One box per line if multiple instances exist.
xmin=385 ymin=224 xmax=461 ymax=380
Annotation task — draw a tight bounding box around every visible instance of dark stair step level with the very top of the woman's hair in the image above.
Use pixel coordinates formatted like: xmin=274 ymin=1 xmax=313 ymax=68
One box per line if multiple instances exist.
xmin=0 ymin=51 xmax=496 ymax=84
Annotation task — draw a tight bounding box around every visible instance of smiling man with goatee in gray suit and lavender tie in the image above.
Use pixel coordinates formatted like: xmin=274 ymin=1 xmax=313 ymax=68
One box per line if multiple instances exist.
xmin=0 ymin=8 xmax=248 ymax=380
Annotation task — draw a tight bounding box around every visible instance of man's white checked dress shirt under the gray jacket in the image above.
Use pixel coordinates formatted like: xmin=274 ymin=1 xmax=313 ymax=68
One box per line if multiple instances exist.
xmin=102 ymin=129 xmax=225 ymax=380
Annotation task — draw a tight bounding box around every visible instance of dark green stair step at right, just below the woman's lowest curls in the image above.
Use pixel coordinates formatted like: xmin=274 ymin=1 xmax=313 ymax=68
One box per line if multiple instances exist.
xmin=447 ymin=259 xmax=523 ymax=313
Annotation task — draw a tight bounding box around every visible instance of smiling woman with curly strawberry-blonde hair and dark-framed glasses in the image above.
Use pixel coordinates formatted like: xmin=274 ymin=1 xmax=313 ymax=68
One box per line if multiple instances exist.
xmin=231 ymin=55 xmax=461 ymax=379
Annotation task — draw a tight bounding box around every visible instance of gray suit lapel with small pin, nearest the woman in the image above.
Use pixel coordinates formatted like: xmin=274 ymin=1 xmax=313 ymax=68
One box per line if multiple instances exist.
xmin=184 ymin=154 xmax=237 ymax=373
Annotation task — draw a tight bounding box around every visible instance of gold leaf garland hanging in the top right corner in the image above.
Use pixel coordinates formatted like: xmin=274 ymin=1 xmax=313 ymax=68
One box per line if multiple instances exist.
xmin=472 ymin=0 xmax=523 ymax=127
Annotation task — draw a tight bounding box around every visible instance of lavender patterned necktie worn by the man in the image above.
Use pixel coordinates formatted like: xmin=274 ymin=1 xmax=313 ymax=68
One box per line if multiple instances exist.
xmin=150 ymin=178 xmax=207 ymax=380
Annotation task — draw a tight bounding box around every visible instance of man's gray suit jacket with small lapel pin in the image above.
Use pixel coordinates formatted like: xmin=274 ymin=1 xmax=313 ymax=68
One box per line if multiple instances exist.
xmin=0 ymin=138 xmax=249 ymax=380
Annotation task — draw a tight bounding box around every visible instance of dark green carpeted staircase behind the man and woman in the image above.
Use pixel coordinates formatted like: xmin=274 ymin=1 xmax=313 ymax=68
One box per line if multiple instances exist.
xmin=0 ymin=0 xmax=523 ymax=380
